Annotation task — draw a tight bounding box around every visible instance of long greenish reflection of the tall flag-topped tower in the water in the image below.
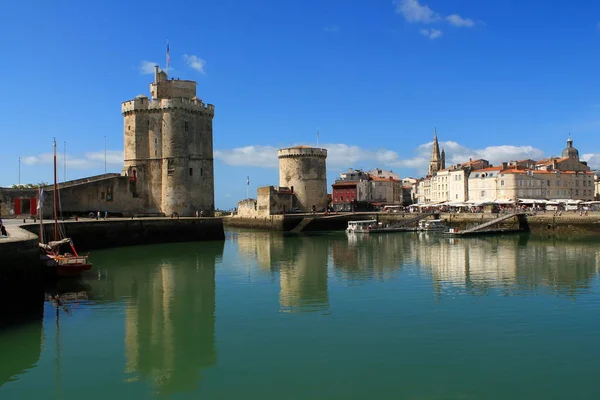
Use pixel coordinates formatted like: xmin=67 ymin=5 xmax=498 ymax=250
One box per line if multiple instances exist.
xmin=125 ymin=245 xmax=216 ymax=394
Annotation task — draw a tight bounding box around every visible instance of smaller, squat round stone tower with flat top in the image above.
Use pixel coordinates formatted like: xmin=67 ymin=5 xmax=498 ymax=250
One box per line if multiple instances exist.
xmin=277 ymin=146 xmax=327 ymax=212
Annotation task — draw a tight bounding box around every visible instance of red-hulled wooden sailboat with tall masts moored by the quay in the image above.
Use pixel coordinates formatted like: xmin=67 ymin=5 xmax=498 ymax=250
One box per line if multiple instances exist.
xmin=38 ymin=139 xmax=92 ymax=277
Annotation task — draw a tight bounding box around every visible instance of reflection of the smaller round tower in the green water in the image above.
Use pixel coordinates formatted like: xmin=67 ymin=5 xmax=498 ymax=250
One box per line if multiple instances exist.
xmin=279 ymin=237 xmax=329 ymax=312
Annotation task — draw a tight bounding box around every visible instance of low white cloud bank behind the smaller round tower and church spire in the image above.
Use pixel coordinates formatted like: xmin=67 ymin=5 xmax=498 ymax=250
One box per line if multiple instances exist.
xmin=215 ymin=141 xmax=548 ymax=175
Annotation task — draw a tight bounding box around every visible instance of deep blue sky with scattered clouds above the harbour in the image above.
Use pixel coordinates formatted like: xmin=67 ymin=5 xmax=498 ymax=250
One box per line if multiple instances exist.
xmin=0 ymin=0 xmax=600 ymax=208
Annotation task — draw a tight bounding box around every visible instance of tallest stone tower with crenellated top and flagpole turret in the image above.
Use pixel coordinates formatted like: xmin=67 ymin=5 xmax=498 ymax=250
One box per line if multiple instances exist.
xmin=121 ymin=66 xmax=215 ymax=216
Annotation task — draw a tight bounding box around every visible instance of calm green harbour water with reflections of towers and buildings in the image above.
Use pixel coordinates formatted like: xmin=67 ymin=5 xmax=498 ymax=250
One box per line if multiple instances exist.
xmin=0 ymin=230 xmax=600 ymax=400
